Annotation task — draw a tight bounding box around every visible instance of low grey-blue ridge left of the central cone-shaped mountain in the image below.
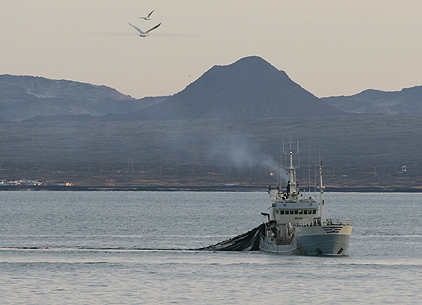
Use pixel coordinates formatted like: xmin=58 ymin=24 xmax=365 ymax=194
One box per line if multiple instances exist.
xmin=0 ymin=75 xmax=163 ymax=121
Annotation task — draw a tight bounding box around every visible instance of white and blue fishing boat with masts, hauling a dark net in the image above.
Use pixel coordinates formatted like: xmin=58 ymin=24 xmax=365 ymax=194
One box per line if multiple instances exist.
xmin=259 ymin=145 xmax=353 ymax=256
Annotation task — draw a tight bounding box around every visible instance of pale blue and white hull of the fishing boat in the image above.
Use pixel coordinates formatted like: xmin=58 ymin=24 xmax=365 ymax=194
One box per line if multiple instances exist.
xmin=259 ymin=226 xmax=352 ymax=256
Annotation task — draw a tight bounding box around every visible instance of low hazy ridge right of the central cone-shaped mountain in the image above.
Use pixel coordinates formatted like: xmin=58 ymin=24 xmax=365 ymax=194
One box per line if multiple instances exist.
xmin=321 ymin=86 xmax=422 ymax=114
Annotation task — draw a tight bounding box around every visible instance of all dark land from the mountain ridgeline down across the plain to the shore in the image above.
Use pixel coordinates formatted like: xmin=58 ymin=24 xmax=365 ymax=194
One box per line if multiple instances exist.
xmin=0 ymin=56 xmax=422 ymax=190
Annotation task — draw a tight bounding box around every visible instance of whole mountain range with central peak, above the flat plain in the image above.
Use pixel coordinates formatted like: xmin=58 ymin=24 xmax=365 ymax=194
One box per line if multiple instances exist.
xmin=0 ymin=56 xmax=422 ymax=122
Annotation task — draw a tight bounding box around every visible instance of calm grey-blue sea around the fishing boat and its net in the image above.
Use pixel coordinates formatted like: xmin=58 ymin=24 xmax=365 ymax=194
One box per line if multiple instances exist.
xmin=0 ymin=191 xmax=422 ymax=304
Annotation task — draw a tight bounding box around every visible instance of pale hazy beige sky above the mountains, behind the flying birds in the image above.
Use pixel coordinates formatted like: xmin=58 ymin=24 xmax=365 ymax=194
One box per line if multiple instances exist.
xmin=0 ymin=0 xmax=422 ymax=98
